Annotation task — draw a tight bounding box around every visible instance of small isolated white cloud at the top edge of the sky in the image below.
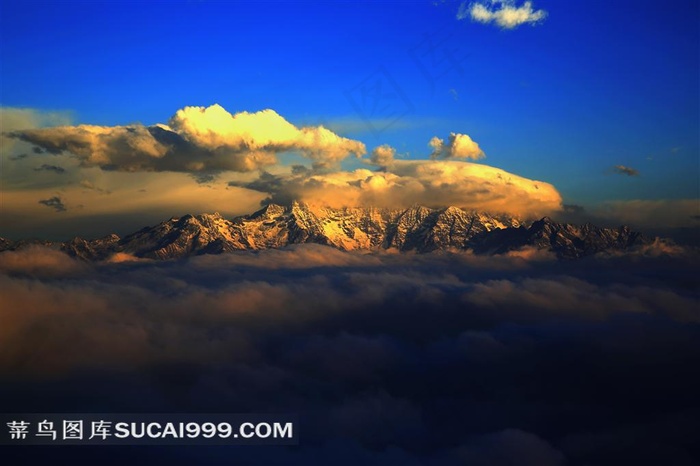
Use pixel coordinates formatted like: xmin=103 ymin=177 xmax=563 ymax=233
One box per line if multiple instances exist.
xmin=457 ymin=0 xmax=547 ymax=29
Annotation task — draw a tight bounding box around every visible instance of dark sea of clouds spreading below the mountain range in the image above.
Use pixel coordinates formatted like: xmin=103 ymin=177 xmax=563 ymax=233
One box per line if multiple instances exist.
xmin=0 ymin=245 xmax=700 ymax=466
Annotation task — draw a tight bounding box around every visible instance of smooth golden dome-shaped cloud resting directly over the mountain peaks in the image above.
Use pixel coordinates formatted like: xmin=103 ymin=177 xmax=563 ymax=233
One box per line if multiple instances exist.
xmin=233 ymin=161 xmax=562 ymax=217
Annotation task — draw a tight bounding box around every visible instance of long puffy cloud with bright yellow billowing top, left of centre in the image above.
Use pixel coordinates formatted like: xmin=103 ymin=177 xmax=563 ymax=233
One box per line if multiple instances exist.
xmin=7 ymin=105 xmax=366 ymax=173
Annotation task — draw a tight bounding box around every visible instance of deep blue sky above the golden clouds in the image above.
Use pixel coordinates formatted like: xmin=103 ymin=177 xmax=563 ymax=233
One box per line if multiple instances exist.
xmin=0 ymin=0 xmax=700 ymax=204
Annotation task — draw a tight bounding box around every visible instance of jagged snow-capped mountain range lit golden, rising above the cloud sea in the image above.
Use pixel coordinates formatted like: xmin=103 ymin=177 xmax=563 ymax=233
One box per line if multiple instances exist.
xmin=0 ymin=202 xmax=652 ymax=260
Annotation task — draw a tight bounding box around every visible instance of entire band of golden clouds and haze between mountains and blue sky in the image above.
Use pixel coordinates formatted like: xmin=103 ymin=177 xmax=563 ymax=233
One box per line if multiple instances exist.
xmin=0 ymin=106 xmax=688 ymax=244
